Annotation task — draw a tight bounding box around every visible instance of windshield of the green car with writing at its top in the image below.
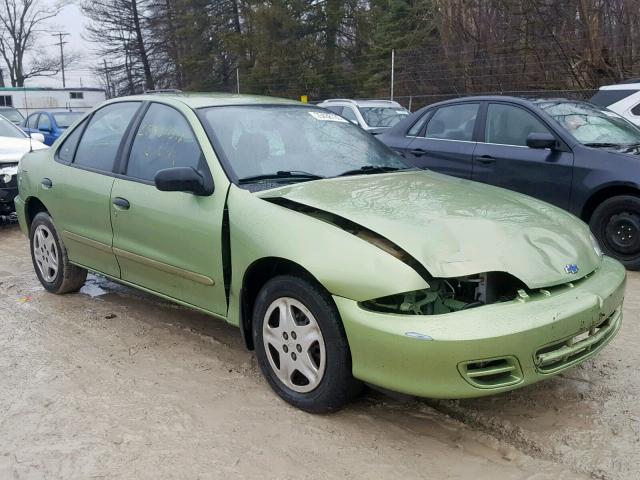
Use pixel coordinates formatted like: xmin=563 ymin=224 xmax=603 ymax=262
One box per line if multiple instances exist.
xmin=203 ymin=105 xmax=408 ymax=186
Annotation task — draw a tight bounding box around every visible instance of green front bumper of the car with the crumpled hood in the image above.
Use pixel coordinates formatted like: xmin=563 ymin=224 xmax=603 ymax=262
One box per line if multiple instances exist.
xmin=334 ymin=257 xmax=626 ymax=398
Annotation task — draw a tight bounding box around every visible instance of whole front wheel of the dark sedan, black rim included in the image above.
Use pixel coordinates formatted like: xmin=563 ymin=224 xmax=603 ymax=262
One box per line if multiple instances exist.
xmin=589 ymin=195 xmax=640 ymax=270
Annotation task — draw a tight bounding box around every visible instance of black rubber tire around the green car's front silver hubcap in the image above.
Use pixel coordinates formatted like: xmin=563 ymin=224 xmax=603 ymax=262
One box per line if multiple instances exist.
xmin=252 ymin=275 xmax=359 ymax=413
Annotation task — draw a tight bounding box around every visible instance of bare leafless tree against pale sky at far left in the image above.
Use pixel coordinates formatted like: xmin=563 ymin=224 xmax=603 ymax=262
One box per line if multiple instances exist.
xmin=0 ymin=0 xmax=64 ymax=87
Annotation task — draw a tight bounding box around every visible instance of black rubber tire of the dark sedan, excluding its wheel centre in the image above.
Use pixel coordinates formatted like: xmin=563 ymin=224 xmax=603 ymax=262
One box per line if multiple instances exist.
xmin=589 ymin=195 xmax=640 ymax=270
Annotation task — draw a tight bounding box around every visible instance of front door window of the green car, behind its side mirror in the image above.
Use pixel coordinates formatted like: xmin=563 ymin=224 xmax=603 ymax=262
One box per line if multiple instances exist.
xmin=127 ymin=103 xmax=205 ymax=182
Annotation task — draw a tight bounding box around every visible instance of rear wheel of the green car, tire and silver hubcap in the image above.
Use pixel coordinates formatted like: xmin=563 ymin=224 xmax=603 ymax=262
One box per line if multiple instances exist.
xmin=29 ymin=212 xmax=87 ymax=295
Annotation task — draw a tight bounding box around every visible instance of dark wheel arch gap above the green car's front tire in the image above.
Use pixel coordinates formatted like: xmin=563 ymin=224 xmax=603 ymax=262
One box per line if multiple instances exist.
xmin=240 ymin=257 xmax=326 ymax=350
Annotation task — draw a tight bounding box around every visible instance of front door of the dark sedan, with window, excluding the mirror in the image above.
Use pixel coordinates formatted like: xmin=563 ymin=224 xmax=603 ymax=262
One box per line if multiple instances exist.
xmin=473 ymin=102 xmax=573 ymax=209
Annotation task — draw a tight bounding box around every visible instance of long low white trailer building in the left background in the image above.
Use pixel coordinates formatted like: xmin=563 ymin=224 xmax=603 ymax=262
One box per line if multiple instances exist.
xmin=0 ymin=87 xmax=107 ymax=116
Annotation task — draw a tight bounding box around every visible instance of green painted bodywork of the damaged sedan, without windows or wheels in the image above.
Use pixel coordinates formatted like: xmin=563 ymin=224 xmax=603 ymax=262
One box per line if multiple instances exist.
xmin=16 ymin=95 xmax=625 ymax=398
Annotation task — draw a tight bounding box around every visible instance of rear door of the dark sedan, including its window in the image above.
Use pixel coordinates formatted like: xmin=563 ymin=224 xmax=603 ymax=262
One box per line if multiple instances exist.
xmin=403 ymin=102 xmax=480 ymax=178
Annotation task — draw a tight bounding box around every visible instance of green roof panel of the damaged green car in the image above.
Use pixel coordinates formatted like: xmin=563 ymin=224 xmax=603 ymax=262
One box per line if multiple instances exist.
xmin=118 ymin=92 xmax=303 ymax=109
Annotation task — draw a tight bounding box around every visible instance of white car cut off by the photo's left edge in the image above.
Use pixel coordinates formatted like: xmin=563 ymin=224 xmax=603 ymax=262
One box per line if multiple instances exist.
xmin=0 ymin=116 xmax=49 ymax=216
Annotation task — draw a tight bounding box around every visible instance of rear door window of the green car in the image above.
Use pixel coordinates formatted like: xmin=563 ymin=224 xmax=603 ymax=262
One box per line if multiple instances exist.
xmin=74 ymin=102 xmax=140 ymax=172
